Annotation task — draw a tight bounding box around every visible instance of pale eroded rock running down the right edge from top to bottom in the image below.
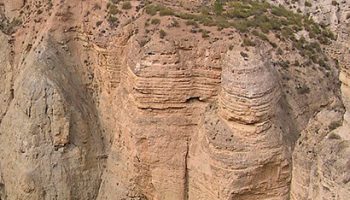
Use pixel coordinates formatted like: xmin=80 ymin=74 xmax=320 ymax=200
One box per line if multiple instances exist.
xmin=270 ymin=1 xmax=350 ymax=200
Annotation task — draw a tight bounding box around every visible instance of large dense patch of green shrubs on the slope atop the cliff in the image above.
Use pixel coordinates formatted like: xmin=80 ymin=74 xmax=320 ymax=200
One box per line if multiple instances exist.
xmin=145 ymin=0 xmax=336 ymax=69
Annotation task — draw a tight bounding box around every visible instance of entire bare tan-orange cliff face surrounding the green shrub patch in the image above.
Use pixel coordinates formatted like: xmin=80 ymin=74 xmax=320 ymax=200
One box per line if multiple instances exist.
xmin=0 ymin=0 xmax=350 ymax=200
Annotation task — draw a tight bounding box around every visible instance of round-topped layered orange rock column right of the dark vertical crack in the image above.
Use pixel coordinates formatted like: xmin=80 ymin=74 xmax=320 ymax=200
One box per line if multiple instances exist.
xmin=189 ymin=48 xmax=290 ymax=200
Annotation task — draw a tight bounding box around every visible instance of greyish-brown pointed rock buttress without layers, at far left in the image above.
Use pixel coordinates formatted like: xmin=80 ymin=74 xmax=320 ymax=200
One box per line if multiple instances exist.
xmin=0 ymin=34 xmax=103 ymax=199
